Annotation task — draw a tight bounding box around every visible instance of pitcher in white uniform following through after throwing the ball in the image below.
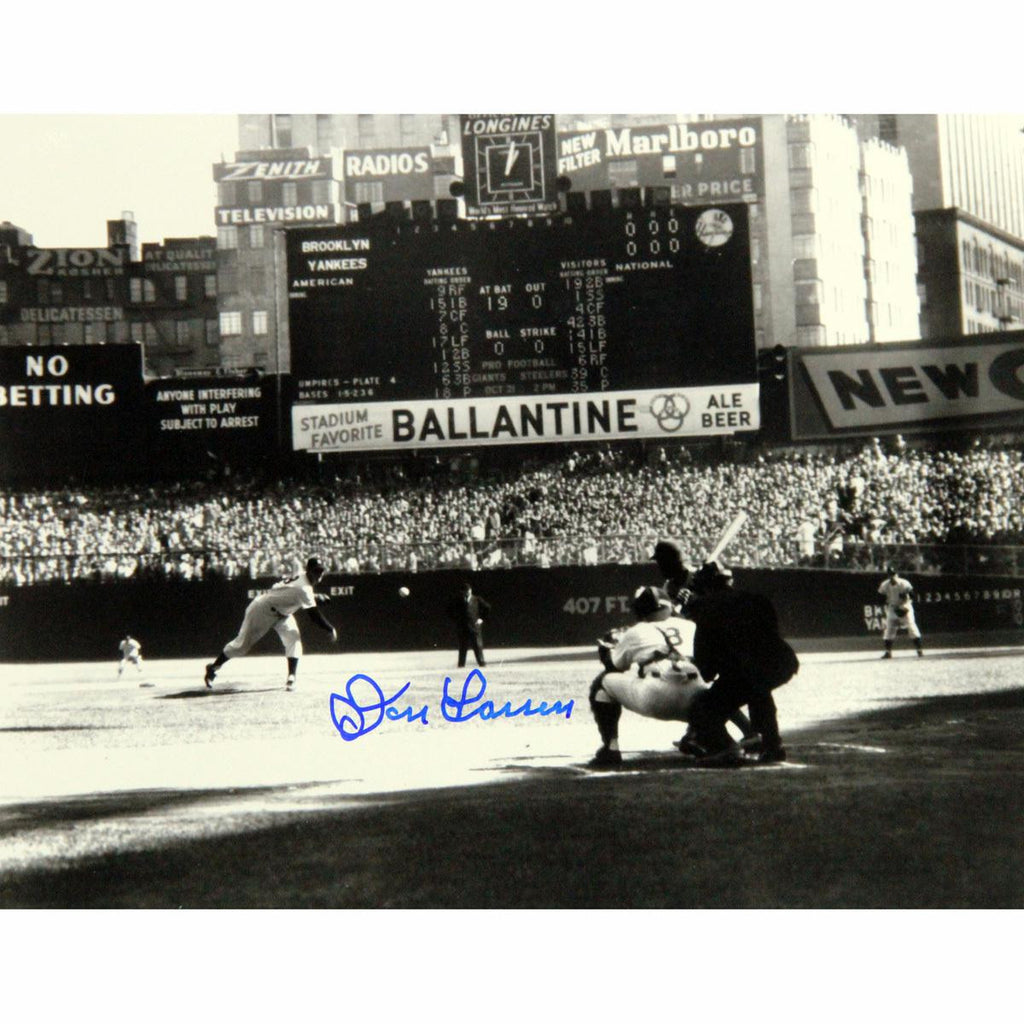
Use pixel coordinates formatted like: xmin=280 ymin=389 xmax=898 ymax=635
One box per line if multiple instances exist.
xmin=203 ymin=558 xmax=338 ymax=689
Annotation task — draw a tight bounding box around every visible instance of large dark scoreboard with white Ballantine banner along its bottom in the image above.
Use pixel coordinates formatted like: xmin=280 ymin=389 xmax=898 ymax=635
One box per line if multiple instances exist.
xmin=287 ymin=204 xmax=757 ymax=451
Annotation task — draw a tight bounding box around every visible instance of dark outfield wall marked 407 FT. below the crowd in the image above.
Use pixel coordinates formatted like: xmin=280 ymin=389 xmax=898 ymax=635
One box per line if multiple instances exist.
xmin=0 ymin=565 xmax=1024 ymax=662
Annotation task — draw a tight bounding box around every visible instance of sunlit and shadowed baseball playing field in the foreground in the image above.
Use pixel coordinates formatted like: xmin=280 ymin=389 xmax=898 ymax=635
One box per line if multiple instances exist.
xmin=0 ymin=645 xmax=1024 ymax=908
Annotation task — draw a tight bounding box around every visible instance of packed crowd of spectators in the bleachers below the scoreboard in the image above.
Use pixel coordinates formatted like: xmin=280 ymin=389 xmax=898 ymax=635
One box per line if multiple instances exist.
xmin=0 ymin=438 xmax=1024 ymax=585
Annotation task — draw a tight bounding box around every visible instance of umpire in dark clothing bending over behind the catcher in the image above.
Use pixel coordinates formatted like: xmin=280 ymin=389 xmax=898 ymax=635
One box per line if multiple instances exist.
xmin=682 ymin=562 xmax=800 ymax=764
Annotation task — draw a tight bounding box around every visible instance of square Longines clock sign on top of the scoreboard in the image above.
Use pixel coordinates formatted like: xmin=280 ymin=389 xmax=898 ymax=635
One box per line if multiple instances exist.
xmin=459 ymin=114 xmax=558 ymax=217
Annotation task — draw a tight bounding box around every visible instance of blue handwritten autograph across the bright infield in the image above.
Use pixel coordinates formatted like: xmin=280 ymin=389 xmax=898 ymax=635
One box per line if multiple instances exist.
xmin=331 ymin=669 xmax=574 ymax=740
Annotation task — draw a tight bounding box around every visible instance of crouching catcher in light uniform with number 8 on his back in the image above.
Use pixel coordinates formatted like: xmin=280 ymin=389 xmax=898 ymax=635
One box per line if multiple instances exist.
xmin=590 ymin=587 xmax=751 ymax=767
